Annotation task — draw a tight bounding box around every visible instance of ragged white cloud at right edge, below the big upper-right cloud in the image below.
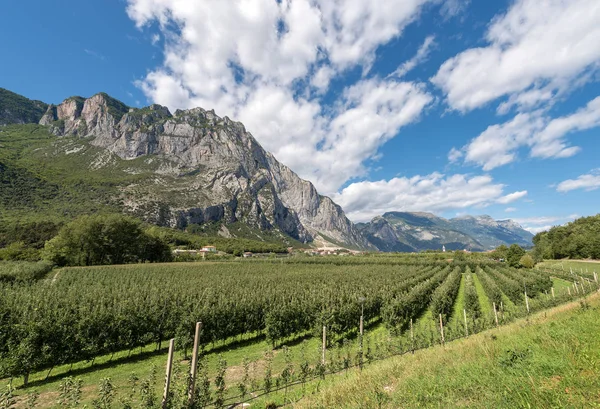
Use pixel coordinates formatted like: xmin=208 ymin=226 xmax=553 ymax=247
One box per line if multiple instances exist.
xmin=448 ymin=97 xmax=600 ymax=171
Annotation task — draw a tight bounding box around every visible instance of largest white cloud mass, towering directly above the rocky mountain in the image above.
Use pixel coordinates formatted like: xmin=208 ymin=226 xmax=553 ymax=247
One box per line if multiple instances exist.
xmin=127 ymin=0 xmax=435 ymax=193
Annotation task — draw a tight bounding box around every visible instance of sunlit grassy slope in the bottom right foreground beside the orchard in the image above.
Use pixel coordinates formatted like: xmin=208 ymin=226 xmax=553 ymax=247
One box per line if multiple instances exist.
xmin=296 ymin=294 xmax=600 ymax=408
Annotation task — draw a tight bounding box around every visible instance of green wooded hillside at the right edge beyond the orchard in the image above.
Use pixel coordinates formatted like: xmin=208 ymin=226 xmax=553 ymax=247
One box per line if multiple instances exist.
xmin=533 ymin=214 xmax=600 ymax=260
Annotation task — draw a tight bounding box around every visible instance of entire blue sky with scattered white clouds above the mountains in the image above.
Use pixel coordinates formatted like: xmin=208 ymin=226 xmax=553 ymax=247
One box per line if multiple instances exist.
xmin=0 ymin=0 xmax=600 ymax=231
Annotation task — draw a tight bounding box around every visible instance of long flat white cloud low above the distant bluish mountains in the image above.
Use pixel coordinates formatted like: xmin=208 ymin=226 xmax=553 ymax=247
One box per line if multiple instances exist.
xmin=332 ymin=173 xmax=522 ymax=221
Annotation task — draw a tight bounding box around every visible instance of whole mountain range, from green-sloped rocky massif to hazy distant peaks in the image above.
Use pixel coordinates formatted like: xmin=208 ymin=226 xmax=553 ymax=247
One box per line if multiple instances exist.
xmin=0 ymin=88 xmax=533 ymax=251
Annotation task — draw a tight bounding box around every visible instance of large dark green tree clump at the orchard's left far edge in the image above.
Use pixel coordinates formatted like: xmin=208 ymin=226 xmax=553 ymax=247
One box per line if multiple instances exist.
xmin=44 ymin=215 xmax=171 ymax=266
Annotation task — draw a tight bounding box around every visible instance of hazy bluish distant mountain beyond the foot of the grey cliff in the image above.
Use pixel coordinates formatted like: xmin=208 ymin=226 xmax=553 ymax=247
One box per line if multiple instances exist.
xmin=357 ymin=212 xmax=533 ymax=251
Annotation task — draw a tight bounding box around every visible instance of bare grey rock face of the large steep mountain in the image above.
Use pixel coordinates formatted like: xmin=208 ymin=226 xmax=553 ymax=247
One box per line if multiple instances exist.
xmin=39 ymin=93 xmax=372 ymax=248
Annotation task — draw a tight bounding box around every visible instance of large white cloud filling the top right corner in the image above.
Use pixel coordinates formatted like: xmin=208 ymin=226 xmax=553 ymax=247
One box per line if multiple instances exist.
xmin=432 ymin=0 xmax=600 ymax=113
